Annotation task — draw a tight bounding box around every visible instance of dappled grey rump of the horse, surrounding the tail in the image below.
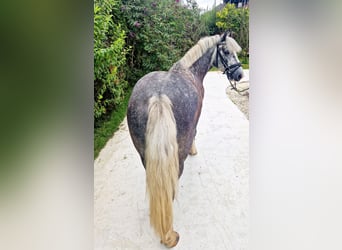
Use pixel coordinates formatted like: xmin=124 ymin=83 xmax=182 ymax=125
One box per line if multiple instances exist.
xmin=127 ymin=71 xmax=203 ymax=169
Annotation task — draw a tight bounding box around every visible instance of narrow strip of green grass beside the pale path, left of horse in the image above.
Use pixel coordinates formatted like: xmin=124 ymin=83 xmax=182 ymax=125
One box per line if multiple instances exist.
xmin=94 ymin=88 xmax=132 ymax=159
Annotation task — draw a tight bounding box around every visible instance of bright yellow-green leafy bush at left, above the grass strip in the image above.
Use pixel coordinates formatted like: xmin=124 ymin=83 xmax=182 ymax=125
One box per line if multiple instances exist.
xmin=94 ymin=0 xmax=127 ymax=122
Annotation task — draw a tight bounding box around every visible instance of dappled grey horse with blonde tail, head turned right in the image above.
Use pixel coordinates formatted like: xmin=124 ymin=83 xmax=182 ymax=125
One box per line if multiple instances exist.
xmin=127 ymin=33 xmax=243 ymax=247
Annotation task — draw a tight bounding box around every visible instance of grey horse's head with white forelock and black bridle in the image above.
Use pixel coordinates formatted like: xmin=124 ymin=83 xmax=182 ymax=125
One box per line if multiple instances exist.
xmin=213 ymin=32 xmax=243 ymax=81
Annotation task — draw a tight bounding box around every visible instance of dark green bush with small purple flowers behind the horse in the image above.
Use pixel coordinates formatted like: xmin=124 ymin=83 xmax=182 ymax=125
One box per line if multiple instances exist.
xmin=122 ymin=0 xmax=204 ymax=84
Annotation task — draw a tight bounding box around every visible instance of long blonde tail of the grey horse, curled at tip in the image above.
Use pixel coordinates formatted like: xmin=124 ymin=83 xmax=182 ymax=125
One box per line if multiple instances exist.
xmin=145 ymin=95 xmax=179 ymax=247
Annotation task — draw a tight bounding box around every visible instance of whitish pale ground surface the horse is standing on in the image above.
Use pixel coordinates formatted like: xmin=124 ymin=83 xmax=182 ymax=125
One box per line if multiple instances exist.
xmin=94 ymin=72 xmax=249 ymax=250
